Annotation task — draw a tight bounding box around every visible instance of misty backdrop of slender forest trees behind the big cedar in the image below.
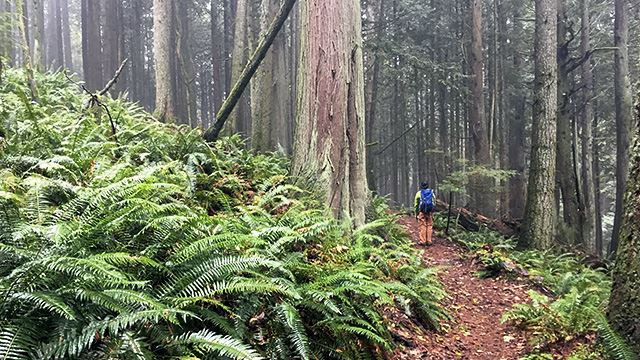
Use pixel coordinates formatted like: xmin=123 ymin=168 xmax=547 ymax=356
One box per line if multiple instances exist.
xmin=0 ymin=0 xmax=640 ymax=255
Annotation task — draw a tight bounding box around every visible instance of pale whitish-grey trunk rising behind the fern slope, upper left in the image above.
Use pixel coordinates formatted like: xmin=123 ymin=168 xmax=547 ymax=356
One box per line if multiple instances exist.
xmin=153 ymin=0 xmax=176 ymax=122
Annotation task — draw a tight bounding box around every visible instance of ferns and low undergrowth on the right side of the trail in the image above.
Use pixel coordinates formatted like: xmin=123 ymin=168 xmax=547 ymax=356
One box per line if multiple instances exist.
xmin=436 ymin=216 xmax=636 ymax=360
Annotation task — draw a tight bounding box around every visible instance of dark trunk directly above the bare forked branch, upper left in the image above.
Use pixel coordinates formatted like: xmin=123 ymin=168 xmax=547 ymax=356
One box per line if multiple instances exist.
xmin=82 ymin=0 xmax=104 ymax=91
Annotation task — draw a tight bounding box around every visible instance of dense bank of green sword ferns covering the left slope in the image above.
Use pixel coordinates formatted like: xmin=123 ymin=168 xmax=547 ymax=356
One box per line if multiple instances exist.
xmin=0 ymin=69 xmax=446 ymax=359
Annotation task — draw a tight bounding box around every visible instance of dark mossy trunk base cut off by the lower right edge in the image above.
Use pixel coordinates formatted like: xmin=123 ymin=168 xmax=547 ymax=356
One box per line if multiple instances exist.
xmin=609 ymin=92 xmax=640 ymax=351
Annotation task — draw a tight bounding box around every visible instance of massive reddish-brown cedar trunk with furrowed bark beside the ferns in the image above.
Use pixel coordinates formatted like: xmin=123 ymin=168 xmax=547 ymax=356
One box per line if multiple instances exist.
xmin=293 ymin=0 xmax=367 ymax=225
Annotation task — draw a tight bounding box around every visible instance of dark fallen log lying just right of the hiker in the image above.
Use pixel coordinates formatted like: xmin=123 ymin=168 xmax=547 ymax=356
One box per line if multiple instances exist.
xmin=436 ymin=200 xmax=521 ymax=237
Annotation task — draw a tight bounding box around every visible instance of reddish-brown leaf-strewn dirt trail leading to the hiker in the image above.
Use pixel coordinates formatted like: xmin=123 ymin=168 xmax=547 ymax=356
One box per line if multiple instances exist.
xmin=391 ymin=217 xmax=528 ymax=360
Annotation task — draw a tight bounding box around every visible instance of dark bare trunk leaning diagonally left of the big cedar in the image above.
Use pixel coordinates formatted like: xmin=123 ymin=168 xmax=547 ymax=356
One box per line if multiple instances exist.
xmin=203 ymin=0 xmax=296 ymax=142
